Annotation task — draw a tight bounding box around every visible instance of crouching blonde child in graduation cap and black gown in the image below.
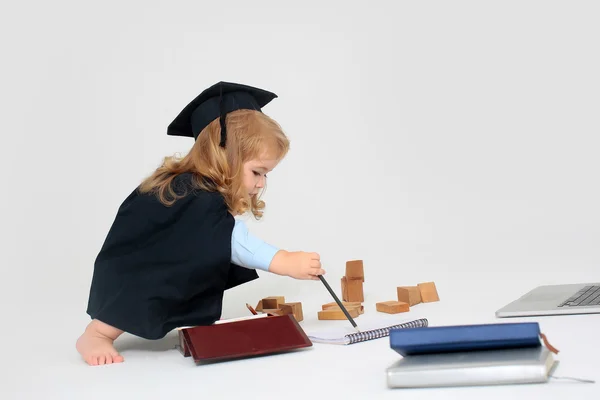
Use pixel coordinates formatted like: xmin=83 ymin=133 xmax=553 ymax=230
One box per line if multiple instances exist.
xmin=76 ymin=82 xmax=325 ymax=365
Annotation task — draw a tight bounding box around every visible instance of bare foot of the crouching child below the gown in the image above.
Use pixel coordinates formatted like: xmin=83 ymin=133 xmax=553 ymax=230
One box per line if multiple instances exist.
xmin=75 ymin=319 xmax=123 ymax=365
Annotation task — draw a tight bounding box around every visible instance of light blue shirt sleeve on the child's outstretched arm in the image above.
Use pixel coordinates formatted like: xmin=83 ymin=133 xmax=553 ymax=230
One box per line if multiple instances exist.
xmin=231 ymin=218 xmax=279 ymax=271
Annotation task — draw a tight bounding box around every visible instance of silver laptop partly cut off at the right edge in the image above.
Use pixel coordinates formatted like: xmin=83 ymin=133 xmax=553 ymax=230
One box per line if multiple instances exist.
xmin=496 ymin=283 xmax=600 ymax=318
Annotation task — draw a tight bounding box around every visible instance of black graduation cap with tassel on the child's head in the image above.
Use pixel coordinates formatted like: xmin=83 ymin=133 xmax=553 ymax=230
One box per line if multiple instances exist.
xmin=167 ymin=82 xmax=277 ymax=147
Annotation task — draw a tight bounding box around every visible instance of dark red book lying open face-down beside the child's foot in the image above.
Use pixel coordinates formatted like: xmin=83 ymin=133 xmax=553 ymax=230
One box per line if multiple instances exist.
xmin=179 ymin=314 xmax=312 ymax=362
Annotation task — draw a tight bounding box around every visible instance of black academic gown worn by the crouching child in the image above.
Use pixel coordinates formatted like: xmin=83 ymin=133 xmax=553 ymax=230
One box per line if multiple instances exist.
xmin=87 ymin=173 xmax=258 ymax=339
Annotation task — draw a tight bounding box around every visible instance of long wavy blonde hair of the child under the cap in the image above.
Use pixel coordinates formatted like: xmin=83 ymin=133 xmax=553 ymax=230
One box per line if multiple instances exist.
xmin=138 ymin=110 xmax=290 ymax=219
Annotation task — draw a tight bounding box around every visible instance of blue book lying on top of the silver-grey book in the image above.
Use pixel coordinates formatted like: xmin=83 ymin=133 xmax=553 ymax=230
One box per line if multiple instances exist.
xmin=390 ymin=322 xmax=541 ymax=356
